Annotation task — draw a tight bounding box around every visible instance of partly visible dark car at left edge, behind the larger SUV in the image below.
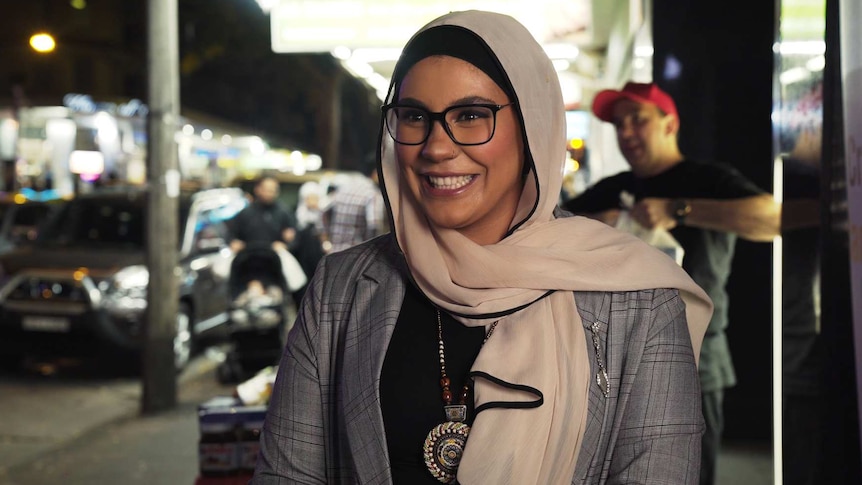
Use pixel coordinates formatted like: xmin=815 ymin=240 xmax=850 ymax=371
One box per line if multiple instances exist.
xmin=0 ymin=194 xmax=59 ymax=254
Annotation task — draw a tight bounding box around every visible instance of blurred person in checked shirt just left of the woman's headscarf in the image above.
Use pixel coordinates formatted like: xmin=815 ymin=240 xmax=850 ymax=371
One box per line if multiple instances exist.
xmin=326 ymin=155 xmax=388 ymax=251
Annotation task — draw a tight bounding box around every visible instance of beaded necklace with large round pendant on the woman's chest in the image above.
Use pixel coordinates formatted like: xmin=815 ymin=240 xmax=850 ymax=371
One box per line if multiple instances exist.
xmin=422 ymin=309 xmax=499 ymax=483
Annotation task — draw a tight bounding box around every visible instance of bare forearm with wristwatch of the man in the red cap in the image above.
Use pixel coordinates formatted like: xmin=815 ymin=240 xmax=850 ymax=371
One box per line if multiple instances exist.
xmin=632 ymin=194 xmax=781 ymax=242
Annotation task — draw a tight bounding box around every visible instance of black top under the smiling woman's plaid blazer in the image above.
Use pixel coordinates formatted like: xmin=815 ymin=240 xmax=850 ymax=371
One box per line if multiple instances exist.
xmin=380 ymin=285 xmax=485 ymax=485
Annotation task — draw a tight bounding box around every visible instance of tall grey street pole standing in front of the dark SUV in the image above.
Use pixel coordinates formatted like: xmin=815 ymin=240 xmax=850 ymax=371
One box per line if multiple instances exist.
xmin=141 ymin=0 xmax=180 ymax=414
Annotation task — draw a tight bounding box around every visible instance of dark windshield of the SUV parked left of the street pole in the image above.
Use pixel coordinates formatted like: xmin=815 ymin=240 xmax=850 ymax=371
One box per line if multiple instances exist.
xmin=38 ymin=198 xmax=146 ymax=249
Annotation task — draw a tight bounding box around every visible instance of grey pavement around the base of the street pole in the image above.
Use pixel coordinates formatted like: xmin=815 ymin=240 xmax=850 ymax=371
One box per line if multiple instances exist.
xmin=0 ymin=348 xmax=240 ymax=485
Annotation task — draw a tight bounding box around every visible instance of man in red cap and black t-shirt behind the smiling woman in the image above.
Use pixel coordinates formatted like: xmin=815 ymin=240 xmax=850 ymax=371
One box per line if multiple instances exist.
xmin=564 ymin=82 xmax=781 ymax=485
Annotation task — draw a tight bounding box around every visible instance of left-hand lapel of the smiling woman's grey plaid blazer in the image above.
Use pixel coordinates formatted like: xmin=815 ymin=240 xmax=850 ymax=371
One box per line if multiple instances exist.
xmin=341 ymin=255 xmax=405 ymax=483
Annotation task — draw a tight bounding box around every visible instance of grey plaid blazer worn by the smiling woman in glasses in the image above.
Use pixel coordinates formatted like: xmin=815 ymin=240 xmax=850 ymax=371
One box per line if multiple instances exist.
xmin=251 ymin=235 xmax=703 ymax=485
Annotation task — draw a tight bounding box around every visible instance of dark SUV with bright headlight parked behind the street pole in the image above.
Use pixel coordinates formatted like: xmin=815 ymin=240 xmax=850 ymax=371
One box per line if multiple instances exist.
xmin=0 ymin=188 xmax=248 ymax=369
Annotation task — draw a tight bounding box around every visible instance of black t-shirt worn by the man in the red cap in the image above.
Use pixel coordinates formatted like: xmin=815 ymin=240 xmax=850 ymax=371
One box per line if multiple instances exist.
xmin=563 ymin=160 xmax=764 ymax=391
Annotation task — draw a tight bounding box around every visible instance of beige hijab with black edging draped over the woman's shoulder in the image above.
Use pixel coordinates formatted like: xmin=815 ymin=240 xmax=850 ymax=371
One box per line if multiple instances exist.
xmin=380 ymin=11 xmax=712 ymax=485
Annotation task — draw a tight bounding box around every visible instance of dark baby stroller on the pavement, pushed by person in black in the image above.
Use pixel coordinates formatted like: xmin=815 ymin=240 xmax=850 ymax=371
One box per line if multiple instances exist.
xmin=217 ymin=245 xmax=292 ymax=383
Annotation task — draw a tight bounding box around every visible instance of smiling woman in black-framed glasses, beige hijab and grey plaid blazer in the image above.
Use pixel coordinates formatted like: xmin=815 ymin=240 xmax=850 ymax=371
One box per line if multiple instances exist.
xmin=252 ymin=11 xmax=712 ymax=485
